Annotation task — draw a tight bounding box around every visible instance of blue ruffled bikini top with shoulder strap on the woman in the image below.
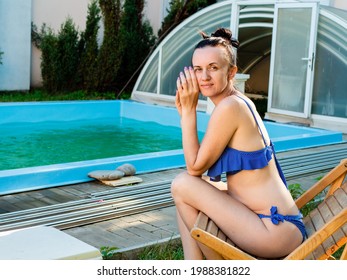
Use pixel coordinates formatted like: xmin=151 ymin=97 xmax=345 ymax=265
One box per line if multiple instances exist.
xmin=207 ymin=95 xmax=287 ymax=186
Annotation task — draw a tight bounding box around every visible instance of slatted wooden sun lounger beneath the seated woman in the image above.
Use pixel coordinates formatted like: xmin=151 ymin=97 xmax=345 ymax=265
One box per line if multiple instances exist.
xmin=191 ymin=159 xmax=347 ymax=260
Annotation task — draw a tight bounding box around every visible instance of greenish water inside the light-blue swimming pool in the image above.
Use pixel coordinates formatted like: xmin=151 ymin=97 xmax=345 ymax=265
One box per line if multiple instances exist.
xmin=0 ymin=117 xmax=189 ymax=170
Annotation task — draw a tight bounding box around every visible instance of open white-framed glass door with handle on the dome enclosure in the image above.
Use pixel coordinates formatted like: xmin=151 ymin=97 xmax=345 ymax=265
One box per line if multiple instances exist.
xmin=268 ymin=2 xmax=318 ymax=118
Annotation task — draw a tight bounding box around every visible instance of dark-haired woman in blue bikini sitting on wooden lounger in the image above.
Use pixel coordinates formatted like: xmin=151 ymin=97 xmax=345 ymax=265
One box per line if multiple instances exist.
xmin=171 ymin=28 xmax=306 ymax=259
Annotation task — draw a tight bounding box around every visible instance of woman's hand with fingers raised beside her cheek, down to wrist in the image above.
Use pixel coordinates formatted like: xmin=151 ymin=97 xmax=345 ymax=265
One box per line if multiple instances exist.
xmin=175 ymin=67 xmax=199 ymax=115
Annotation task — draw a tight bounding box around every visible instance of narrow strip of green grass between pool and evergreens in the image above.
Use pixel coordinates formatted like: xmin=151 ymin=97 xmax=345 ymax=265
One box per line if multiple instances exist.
xmin=0 ymin=89 xmax=131 ymax=102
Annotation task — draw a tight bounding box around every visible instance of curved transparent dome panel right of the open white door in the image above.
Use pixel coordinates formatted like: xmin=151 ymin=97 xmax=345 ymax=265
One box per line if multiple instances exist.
xmin=312 ymin=12 xmax=347 ymax=118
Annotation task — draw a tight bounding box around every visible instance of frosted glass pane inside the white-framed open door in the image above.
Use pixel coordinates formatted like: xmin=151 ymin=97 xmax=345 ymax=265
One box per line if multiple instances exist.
xmin=271 ymin=8 xmax=311 ymax=113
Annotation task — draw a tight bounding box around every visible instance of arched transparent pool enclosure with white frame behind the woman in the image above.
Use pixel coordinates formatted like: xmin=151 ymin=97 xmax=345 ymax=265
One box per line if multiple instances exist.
xmin=131 ymin=0 xmax=347 ymax=133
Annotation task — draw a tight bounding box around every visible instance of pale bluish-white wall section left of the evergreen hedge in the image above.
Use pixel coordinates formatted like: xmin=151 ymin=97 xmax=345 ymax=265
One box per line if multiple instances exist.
xmin=0 ymin=0 xmax=31 ymax=91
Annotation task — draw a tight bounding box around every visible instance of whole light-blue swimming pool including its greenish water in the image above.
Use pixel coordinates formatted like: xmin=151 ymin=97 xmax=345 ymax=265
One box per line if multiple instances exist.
xmin=0 ymin=100 xmax=343 ymax=195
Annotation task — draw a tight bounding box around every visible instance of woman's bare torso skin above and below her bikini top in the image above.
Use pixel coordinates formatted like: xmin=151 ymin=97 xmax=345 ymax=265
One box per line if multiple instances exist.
xmin=215 ymin=95 xmax=298 ymax=215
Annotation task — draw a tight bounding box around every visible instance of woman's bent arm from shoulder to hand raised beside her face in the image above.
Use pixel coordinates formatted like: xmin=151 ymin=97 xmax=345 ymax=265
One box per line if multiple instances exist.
xmin=176 ymin=69 xmax=238 ymax=176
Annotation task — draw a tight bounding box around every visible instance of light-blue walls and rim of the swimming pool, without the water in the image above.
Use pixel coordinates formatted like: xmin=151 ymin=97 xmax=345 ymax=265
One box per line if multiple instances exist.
xmin=0 ymin=100 xmax=342 ymax=195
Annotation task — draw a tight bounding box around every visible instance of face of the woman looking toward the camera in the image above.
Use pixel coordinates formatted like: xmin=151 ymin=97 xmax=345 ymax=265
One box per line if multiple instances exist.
xmin=192 ymin=47 xmax=234 ymax=97
